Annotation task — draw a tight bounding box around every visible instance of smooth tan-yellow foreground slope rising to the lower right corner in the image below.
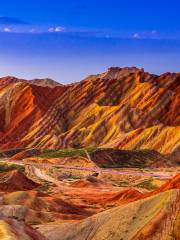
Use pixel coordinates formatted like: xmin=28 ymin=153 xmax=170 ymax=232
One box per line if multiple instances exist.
xmin=39 ymin=190 xmax=180 ymax=240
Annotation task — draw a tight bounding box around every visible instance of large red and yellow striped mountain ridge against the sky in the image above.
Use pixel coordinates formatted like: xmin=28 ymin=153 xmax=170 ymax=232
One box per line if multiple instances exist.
xmin=0 ymin=67 xmax=180 ymax=158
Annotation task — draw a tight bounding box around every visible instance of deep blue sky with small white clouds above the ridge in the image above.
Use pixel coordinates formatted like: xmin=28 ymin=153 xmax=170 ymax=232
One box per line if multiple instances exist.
xmin=0 ymin=0 xmax=180 ymax=83
